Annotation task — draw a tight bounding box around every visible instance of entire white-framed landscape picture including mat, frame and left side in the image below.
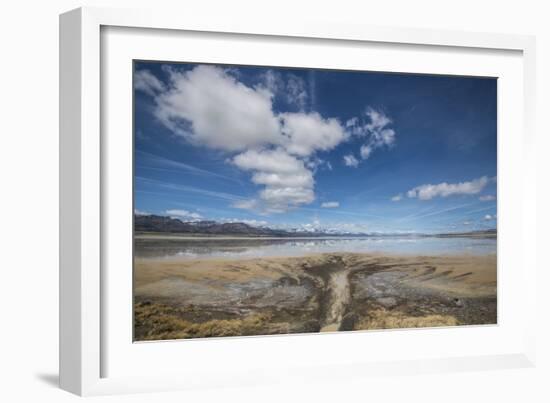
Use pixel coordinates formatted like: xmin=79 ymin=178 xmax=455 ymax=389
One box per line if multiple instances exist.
xmin=60 ymin=9 xmax=536 ymax=395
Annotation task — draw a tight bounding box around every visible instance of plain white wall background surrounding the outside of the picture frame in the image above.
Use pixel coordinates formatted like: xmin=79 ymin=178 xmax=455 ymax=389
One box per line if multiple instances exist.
xmin=0 ymin=0 xmax=550 ymax=403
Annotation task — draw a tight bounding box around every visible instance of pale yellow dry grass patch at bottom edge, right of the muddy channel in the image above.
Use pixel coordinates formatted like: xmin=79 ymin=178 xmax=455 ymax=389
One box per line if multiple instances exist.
xmin=355 ymin=309 xmax=459 ymax=330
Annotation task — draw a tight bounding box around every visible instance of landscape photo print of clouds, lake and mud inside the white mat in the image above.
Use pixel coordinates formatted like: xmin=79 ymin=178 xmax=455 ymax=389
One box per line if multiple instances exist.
xmin=134 ymin=61 xmax=497 ymax=341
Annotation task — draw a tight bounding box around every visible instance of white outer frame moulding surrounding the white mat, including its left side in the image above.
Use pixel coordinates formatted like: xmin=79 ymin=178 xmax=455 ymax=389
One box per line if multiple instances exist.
xmin=59 ymin=8 xmax=537 ymax=395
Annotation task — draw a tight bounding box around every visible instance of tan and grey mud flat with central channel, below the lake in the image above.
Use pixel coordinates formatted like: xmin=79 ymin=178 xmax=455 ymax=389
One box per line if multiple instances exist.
xmin=134 ymin=253 xmax=497 ymax=340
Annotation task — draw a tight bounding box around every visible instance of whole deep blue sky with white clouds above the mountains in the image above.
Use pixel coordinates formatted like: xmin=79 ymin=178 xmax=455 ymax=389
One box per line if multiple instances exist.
xmin=134 ymin=62 xmax=497 ymax=232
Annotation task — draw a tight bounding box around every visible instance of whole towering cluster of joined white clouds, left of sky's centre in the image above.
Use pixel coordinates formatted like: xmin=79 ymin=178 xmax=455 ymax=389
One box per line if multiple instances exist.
xmin=146 ymin=65 xmax=395 ymax=213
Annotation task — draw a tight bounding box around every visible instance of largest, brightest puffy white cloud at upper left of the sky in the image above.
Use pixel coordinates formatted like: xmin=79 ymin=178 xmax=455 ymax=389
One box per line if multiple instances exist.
xmin=155 ymin=65 xmax=283 ymax=151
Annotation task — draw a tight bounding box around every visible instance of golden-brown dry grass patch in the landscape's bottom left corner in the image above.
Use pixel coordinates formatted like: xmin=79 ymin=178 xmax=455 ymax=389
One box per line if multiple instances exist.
xmin=135 ymin=303 xmax=271 ymax=341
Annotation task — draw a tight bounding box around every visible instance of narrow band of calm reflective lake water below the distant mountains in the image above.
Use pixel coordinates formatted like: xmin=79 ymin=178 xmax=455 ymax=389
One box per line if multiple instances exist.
xmin=135 ymin=236 xmax=497 ymax=260
